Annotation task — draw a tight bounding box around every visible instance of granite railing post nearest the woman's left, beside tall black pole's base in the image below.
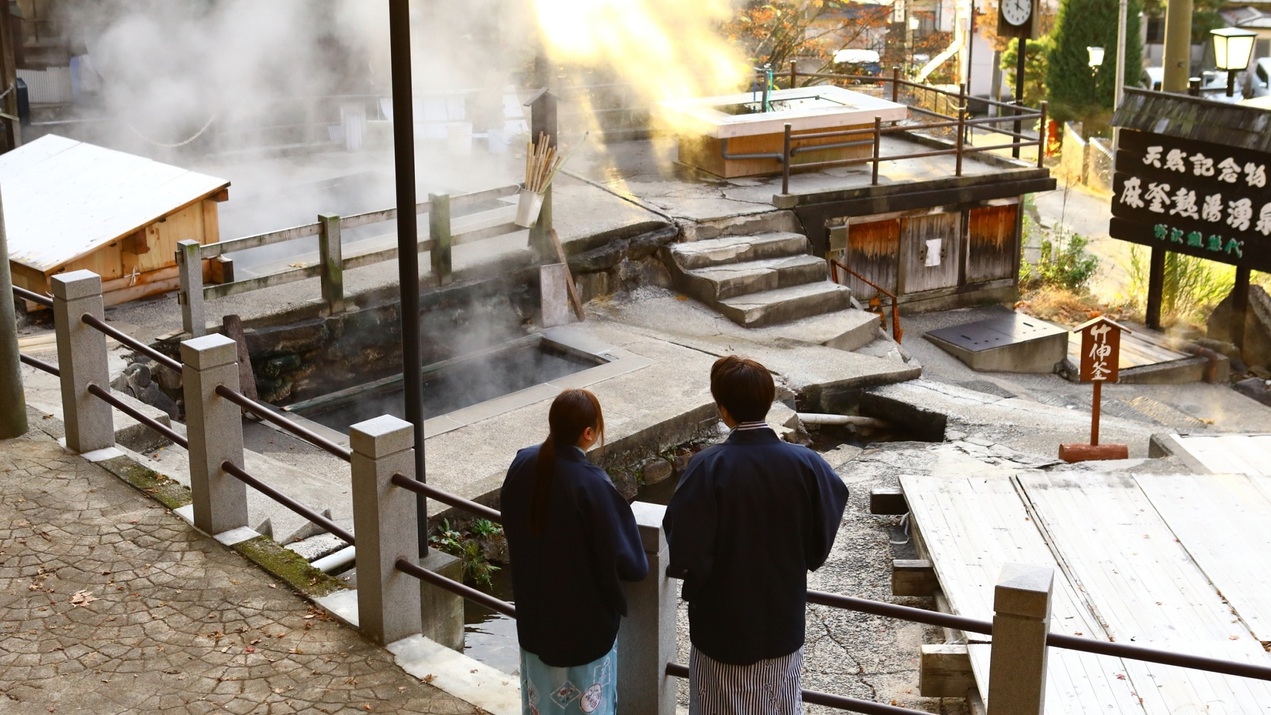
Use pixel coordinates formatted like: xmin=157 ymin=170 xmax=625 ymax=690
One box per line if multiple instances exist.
xmin=348 ymin=415 xmax=421 ymax=645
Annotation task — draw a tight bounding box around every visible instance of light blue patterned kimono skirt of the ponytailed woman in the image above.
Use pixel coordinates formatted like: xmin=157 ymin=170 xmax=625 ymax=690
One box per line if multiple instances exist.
xmin=521 ymin=643 xmax=618 ymax=715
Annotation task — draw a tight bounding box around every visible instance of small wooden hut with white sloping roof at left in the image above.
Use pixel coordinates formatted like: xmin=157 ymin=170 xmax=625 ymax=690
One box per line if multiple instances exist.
xmin=0 ymin=135 xmax=230 ymax=305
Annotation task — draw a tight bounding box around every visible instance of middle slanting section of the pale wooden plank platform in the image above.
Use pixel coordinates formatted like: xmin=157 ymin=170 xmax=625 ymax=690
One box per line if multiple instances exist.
xmin=1018 ymin=472 xmax=1271 ymax=714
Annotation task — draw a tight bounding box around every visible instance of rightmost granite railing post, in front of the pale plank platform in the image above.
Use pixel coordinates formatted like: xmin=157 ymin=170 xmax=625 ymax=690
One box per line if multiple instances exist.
xmin=989 ymin=564 xmax=1055 ymax=715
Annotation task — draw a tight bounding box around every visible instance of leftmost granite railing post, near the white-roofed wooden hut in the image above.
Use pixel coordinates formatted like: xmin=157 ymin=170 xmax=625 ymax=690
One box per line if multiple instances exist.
xmin=52 ymin=271 xmax=114 ymax=453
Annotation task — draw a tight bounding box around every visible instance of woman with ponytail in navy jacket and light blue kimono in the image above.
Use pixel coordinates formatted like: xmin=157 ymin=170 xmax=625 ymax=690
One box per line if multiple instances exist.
xmin=500 ymin=390 xmax=648 ymax=715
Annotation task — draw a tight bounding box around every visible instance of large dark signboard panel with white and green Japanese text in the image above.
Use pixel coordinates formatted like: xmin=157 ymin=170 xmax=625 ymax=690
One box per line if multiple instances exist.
xmin=1111 ymin=131 xmax=1271 ymax=271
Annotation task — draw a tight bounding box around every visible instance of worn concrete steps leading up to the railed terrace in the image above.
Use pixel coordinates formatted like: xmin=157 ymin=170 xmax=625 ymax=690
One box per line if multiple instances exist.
xmin=663 ymin=231 xmax=878 ymax=349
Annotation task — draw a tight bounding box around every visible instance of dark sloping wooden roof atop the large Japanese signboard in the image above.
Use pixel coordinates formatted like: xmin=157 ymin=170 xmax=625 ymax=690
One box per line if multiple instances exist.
xmin=1112 ymin=88 xmax=1271 ymax=154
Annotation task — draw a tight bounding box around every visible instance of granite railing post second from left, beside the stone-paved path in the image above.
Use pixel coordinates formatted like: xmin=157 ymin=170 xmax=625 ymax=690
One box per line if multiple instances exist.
xmin=180 ymin=334 xmax=247 ymax=536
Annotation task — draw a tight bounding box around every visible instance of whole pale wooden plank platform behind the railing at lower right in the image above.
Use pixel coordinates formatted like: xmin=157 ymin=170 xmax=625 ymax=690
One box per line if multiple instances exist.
xmin=901 ymin=472 xmax=1271 ymax=715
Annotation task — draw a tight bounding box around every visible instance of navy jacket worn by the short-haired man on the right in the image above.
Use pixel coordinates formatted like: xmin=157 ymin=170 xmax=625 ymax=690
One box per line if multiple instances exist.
xmin=662 ymin=428 xmax=848 ymax=665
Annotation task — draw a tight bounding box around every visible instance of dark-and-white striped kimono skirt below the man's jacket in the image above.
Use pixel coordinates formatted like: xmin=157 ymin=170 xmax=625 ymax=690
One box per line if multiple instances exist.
xmin=689 ymin=648 xmax=803 ymax=715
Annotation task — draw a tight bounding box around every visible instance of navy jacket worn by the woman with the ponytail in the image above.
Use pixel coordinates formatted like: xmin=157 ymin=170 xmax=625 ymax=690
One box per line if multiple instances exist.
xmin=501 ymin=446 xmax=648 ymax=667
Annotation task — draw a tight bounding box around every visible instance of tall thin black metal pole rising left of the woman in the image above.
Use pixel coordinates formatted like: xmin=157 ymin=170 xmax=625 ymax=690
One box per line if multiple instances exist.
xmin=389 ymin=0 xmax=428 ymax=558
